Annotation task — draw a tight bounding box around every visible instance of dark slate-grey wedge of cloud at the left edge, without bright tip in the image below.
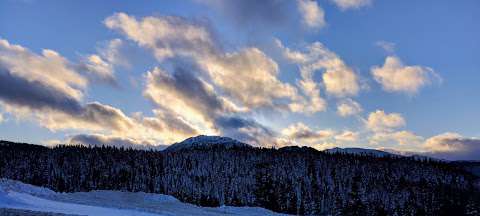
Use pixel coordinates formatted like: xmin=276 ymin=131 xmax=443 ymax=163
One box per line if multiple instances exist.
xmin=0 ymin=68 xmax=83 ymax=115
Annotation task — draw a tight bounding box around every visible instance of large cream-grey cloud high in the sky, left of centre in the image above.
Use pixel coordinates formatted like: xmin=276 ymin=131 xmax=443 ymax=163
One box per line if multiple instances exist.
xmin=104 ymin=13 xmax=216 ymax=60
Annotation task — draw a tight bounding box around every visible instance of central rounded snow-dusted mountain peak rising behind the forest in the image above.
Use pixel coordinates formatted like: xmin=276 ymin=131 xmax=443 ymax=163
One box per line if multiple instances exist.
xmin=164 ymin=135 xmax=251 ymax=152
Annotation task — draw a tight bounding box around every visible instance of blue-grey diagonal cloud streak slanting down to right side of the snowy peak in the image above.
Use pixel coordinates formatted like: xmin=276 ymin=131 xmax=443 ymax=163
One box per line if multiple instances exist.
xmin=147 ymin=64 xmax=282 ymax=146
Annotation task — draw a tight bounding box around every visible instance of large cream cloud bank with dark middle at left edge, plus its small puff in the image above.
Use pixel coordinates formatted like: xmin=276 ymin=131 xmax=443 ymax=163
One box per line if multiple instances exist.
xmin=0 ymin=40 xmax=145 ymax=141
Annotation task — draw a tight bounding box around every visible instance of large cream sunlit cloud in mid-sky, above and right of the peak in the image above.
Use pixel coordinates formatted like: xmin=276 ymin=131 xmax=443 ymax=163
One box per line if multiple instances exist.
xmin=199 ymin=48 xmax=297 ymax=108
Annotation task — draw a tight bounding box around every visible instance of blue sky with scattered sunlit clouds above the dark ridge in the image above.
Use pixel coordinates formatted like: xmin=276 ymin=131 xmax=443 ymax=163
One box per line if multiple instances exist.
xmin=0 ymin=0 xmax=480 ymax=160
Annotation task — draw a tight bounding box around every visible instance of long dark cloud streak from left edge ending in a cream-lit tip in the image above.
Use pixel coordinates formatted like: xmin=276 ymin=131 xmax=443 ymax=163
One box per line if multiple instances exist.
xmin=0 ymin=66 xmax=133 ymax=131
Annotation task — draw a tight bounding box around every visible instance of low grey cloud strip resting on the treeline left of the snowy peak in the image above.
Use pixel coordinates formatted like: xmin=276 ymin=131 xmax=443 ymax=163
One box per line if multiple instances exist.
xmin=68 ymin=134 xmax=167 ymax=150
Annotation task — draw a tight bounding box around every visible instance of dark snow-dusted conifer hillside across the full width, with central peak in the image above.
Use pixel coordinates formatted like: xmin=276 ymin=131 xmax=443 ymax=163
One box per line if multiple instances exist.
xmin=0 ymin=137 xmax=480 ymax=215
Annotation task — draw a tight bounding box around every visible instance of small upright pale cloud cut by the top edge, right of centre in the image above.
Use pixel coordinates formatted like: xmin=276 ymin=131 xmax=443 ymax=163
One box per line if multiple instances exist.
xmin=297 ymin=0 xmax=326 ymax=29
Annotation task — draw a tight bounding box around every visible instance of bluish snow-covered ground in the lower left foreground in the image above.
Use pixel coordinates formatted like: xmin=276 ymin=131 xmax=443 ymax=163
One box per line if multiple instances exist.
xmin=0 ymin=179 xmax=281 ymax=216
